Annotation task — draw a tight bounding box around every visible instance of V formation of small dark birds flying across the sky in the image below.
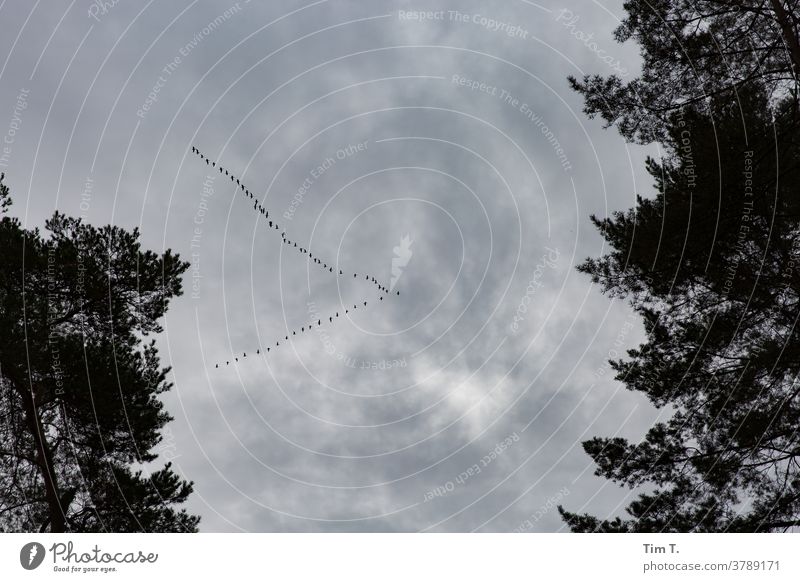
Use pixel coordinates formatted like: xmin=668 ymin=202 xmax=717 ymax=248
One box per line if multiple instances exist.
xmin=192 ymin=146 xmax=400 ymax=368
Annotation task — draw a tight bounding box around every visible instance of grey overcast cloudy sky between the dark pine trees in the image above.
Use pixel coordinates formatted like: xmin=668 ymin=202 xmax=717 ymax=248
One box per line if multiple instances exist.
xmin=0 ymin=0 xmax=665 ymax=532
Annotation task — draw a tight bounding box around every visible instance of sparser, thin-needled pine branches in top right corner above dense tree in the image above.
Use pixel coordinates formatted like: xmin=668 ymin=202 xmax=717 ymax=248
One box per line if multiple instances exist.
xmin=570 ymin=0 xmax=800 ymax=143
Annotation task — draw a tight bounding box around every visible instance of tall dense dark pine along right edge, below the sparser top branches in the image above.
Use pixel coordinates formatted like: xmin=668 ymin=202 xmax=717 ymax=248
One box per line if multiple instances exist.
xmin=559 ymin=2 xmax=800 ymax=532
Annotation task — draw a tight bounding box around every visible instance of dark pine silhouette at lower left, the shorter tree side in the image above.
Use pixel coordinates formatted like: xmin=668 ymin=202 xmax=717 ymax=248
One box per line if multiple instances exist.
xmin=0 ymin=178 xmax=199 ymax=532
